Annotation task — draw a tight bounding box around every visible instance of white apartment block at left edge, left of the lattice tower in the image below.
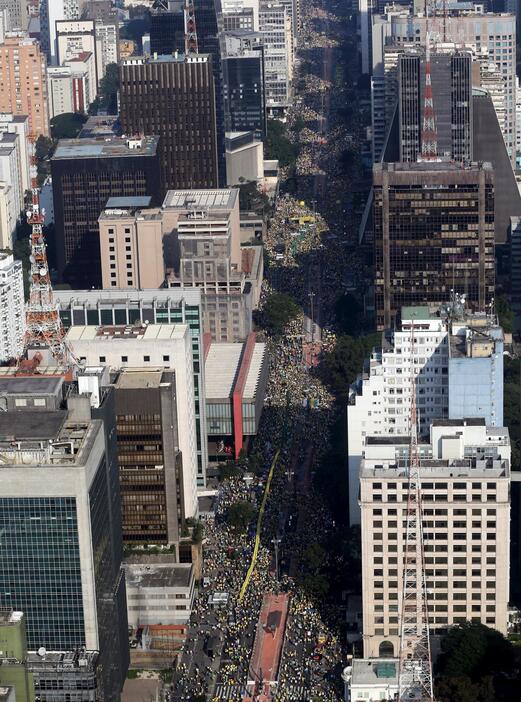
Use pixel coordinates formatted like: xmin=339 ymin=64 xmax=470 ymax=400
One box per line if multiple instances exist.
xmin=0 ymin=251 xmax=25 ymax=362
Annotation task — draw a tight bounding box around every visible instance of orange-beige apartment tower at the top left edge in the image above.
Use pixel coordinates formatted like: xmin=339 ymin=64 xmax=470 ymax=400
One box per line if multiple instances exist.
xmin=0 ymin=32 xmax=49 ymax=136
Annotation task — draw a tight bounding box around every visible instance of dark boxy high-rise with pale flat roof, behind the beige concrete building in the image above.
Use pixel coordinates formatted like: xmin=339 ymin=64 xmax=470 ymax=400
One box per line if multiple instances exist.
xmin=51 ymin=132 xmax=161 ymax=289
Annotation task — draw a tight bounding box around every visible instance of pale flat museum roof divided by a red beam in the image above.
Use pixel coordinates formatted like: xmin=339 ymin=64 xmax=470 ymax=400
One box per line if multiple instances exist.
xmin=205 ymin=342 xmax=266 ymax=401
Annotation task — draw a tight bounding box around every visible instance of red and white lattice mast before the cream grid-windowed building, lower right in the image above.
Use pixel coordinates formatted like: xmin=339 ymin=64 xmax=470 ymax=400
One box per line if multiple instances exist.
xmin=398 ymin=320 xmax=434 ymax=702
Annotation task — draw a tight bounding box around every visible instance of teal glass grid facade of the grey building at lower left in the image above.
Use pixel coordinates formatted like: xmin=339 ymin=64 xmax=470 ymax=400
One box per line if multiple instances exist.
xmin=0 ymin=497 xmax=85 ymax=651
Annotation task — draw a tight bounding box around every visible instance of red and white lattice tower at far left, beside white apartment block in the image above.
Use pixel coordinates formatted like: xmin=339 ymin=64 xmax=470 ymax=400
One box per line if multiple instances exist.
xmin=25 ymin=135 xmax=67 ymax=365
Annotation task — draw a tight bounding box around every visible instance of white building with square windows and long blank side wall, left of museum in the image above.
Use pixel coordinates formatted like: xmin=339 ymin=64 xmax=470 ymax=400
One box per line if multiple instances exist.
xmin=66 ymin=323 xmax=198 ymax=518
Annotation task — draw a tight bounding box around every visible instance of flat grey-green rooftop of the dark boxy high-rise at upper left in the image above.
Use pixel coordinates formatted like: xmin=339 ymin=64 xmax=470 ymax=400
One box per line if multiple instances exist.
xmin=51 ymin=136 xmax=159 ymax=161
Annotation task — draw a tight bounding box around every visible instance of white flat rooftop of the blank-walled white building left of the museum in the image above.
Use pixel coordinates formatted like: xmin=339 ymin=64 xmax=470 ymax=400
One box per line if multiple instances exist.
xmin=65 ymin=324 xmax=188 ymax=342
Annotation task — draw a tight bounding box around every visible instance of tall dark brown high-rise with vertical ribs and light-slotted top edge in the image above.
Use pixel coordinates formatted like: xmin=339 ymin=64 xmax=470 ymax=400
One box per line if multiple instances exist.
xmin=120 ymin=54 xmax=219 ymax=194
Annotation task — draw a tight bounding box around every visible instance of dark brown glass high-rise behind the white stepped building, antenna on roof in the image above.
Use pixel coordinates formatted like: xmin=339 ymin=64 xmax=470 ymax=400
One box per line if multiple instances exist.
xmin=373 ymin=161 xmax=495 ymax=329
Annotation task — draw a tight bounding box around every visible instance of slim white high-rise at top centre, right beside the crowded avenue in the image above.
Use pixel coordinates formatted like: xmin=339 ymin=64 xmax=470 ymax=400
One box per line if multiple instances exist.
xmin=259 ymin=3 xmax=294 ymax=116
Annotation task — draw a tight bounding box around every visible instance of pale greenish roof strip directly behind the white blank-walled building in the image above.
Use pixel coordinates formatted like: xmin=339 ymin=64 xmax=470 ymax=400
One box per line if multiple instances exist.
xmin=54 ymin=288 xmax=201 ymax=308
